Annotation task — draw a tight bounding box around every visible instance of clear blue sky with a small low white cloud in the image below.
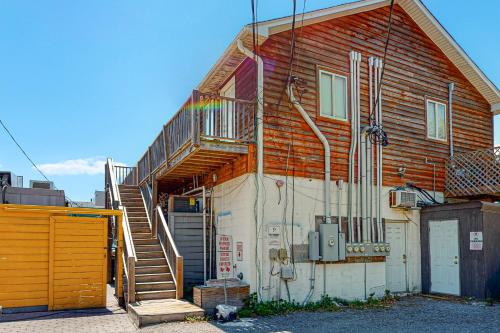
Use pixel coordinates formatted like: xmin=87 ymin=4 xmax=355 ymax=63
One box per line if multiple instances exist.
xmin=0 ymin=0 xmax=500 ymax=200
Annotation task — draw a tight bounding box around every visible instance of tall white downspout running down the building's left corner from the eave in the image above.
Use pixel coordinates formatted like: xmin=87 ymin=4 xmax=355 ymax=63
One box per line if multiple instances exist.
xmin=236 ymin=39 xmax=264 ymax=298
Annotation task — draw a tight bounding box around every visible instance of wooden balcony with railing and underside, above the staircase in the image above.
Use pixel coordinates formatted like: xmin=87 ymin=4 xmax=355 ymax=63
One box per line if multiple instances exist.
xmin=137 ymin=91 xmax=255 ymax=188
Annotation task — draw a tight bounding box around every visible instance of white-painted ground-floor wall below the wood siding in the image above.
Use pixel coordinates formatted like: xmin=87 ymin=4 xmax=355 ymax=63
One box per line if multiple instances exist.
xmin=214 ymin=174 xmax=442 ymax=302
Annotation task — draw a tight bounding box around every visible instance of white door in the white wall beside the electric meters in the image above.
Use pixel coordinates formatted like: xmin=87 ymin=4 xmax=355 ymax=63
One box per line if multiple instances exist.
xmin=385 ymin=223 xmax=408 ymax=293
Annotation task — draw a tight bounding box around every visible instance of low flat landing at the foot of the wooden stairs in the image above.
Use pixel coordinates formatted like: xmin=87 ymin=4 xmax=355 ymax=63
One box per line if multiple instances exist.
xmin=128 ymin=299 xmax=205 ymax=327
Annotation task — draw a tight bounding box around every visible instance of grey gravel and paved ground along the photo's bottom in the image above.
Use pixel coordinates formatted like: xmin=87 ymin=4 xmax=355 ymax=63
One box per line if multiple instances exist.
xmin=0 ymin=296 xmax=500 ymax=333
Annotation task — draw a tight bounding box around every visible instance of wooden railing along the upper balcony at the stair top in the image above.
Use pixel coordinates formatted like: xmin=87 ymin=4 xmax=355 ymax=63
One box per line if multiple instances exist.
xmin=137 ymin=90 xmax=255 ymax=183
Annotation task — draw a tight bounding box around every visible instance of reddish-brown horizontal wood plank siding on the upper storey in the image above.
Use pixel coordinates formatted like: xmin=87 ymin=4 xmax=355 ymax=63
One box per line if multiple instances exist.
xmin=258 ymin=5 xmax=493 ymax=190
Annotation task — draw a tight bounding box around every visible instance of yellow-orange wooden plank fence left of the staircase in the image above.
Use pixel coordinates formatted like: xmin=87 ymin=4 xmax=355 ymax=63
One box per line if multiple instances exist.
xmin=0 ymin=205 xmax=123 ymax=310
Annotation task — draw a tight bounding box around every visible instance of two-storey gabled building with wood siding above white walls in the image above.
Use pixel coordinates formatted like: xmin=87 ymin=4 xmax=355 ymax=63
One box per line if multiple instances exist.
xmin=106 ymin=0 xmax=500 ymax=301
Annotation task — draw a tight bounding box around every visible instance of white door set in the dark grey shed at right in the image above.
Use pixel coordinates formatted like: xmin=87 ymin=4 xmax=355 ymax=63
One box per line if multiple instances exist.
xmin=429 ymin=220 xmax=460 ymax=296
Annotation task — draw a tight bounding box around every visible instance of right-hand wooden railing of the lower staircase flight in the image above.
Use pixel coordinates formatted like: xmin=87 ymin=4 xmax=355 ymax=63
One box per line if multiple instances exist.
xmin=156 ymin=205 xmax=184 ymax=299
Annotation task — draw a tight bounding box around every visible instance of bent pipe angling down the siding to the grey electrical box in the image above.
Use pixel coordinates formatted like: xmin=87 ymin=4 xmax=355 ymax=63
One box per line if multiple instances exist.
xmin=286 ymin=83 xmax=332 ymax=223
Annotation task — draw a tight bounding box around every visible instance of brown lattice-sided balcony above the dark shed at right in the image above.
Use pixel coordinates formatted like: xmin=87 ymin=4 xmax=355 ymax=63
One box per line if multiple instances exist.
xmin=445 ymin=147 xmax=500 ymax=199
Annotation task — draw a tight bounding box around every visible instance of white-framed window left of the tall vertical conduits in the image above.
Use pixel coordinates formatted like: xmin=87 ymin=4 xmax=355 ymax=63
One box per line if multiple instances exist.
xmin=319 ymin=70 xmax=347 ymax=120
